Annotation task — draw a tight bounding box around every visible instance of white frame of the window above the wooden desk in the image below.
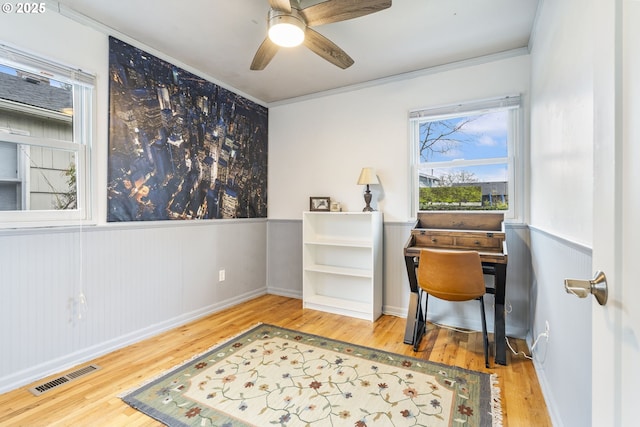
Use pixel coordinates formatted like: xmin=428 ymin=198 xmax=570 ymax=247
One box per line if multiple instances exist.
xmin=409 ymin=95 xmax=524 ymax=222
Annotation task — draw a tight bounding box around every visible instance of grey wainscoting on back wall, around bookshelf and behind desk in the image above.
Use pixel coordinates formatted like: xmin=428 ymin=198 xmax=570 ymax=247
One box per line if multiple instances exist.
xmin=267 ymin=220 xmax=531 ymax=338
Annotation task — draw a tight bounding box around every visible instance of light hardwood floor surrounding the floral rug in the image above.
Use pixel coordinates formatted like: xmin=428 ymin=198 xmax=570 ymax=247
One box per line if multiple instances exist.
xmin=0 ymin=295 xmax=552 ymax=427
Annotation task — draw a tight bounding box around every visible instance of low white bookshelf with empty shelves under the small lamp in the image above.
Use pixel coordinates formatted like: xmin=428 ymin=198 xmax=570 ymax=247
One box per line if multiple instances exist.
xmin=302 ymin=212 xmax=382 ymax=321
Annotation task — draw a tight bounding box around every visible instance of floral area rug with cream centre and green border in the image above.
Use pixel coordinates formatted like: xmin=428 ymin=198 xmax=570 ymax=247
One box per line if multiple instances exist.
xmin=122 ymin=324 xmax=502 ymax=427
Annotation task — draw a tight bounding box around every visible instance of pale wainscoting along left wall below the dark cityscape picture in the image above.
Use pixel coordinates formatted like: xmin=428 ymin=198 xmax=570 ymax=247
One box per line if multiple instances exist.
xmin=0 ymin=219 xmax=267 ymax=393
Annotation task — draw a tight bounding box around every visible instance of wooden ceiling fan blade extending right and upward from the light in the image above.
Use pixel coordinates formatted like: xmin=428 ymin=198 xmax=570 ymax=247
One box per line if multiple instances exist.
xmin=300 ymin=0 xmax=391 ymax=27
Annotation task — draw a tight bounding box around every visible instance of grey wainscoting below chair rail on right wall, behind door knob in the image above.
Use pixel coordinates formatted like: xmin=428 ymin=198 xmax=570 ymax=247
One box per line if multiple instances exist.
xmin=529 ymin=227 xmax=593 ymax=426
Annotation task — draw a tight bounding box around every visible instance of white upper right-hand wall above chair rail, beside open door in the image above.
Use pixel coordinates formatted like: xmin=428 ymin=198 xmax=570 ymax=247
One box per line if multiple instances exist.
xmin=530 ymin=0 xmax=594 ymax=245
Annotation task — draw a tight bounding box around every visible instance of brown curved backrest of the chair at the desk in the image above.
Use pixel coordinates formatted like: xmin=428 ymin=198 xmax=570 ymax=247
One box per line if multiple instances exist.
xmin=418 ymin=249 xmax=486 ymax=301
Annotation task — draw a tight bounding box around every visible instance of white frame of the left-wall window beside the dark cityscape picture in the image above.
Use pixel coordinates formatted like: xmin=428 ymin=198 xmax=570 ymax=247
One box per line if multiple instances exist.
xmin=0 ymin=44 xmax=96 ymax=228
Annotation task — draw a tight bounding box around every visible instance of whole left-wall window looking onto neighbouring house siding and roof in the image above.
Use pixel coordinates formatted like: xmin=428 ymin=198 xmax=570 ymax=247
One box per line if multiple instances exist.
xmin=0 ymin=45 xmax=94 ymax=227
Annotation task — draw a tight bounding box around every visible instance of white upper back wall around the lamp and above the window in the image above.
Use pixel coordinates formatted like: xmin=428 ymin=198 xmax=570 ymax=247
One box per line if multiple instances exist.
xmin=269 ymin=55 xmax=529 ymax=222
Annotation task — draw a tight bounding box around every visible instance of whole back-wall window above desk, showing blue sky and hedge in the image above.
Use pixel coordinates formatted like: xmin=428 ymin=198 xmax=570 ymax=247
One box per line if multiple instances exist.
xmin=410 ymin=96 xmax=521 ymax=219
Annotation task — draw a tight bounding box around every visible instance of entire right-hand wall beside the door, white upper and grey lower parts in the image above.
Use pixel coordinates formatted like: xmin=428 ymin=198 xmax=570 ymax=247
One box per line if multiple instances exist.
xmin=530 ymin=0 xmax=597 ymax=426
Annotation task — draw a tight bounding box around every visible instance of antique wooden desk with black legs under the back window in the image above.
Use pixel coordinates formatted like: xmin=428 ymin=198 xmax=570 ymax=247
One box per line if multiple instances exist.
xmin=404 ymin=212 xmax=507 ymax=365
